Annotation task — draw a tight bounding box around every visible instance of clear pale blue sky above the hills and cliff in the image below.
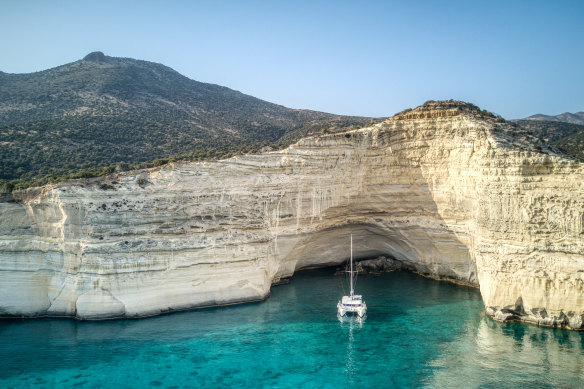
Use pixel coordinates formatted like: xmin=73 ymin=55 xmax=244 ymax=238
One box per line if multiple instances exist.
xmin=0 ymin=0 xmax=584 ymax=119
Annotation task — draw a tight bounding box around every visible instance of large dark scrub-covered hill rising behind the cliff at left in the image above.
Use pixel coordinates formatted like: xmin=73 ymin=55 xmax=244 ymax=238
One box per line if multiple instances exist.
xmin=0 ymin=52 xmax=372 ymax=185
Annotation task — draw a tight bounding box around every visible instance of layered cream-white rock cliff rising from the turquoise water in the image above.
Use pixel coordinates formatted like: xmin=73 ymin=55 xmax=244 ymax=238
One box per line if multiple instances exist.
xmin=0 ymin=101 xmax=584 ymax=328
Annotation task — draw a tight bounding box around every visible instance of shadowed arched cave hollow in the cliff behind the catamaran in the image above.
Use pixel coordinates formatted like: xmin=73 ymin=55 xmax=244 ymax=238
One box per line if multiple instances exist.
xmin=279 ymin=223 xmax=478 ymax=287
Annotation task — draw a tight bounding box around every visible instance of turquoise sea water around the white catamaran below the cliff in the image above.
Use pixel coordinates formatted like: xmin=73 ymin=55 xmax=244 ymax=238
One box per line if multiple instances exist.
xmin=0 ymin=269 xmax=584 ymax=388
